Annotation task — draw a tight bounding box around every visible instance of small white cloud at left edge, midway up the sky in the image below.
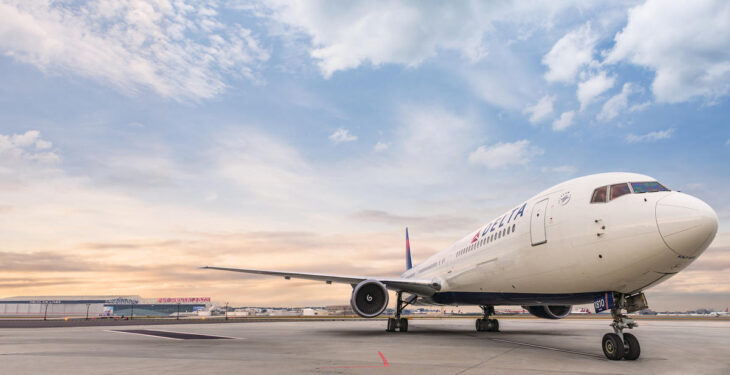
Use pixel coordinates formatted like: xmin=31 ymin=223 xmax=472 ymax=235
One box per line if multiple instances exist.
xmin=0 ymin=130 xmax=60 ymax=166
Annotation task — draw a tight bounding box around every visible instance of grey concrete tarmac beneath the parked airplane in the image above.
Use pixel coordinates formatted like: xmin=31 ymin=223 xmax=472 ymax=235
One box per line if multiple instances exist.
xmin=0 ymin=319 xmax=730 ymax=374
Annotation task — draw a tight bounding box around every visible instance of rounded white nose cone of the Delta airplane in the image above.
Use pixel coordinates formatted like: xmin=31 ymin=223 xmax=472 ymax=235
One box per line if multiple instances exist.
xmin=656 ymin=192 xmax=717 ymax=257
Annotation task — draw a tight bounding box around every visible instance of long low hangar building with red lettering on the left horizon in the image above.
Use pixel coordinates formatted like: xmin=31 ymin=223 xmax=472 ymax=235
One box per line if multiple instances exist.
xmin=0 ymin=295 xmax=213 ymax=318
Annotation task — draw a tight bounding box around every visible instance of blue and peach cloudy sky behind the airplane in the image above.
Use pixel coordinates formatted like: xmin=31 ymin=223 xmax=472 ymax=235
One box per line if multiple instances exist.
xmin=0 ymin=0 xmax=730 ymax=310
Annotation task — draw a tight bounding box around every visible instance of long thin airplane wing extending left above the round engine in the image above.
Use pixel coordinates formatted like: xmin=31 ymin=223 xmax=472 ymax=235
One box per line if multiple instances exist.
xmin=200 ymin=266 xmax=441 ymax=296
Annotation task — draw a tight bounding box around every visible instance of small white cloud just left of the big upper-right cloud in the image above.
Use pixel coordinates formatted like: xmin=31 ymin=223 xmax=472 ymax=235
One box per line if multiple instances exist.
xmin=542 ymin=22 xmax=598 ymax=83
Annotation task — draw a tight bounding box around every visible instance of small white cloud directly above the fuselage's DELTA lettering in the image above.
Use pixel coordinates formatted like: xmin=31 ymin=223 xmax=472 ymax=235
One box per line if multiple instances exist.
xmin=469 ymin=139 xmax=544 ymax=168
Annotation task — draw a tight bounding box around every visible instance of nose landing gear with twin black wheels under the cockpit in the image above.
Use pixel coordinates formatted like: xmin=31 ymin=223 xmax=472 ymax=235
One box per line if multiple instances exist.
xmin=602 ymin=294 xmax=646 ymax=361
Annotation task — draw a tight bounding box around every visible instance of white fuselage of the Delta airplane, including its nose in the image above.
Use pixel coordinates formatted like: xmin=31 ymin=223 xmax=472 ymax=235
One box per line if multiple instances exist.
xmin=402 ymin=173 xmax=718 ymax=305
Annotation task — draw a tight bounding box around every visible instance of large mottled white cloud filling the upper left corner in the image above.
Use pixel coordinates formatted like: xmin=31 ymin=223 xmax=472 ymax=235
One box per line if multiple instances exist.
xmin=0 ymin=0 xmax=269 ymax=100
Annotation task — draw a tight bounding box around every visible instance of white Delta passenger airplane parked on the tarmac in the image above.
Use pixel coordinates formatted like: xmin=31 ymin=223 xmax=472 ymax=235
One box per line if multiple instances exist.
xmin=201 ymin=172 xmax=718 ymax=360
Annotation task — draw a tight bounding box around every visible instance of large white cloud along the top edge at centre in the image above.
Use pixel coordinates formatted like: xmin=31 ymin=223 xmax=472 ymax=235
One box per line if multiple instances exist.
xmin=260 ymin=0 xmax=588 ymax=77
